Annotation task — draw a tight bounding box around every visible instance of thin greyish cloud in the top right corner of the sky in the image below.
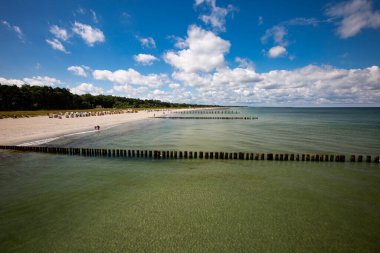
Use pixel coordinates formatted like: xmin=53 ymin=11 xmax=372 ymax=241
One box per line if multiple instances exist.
xmin=326 ymin=0 xmax=380 ymax=38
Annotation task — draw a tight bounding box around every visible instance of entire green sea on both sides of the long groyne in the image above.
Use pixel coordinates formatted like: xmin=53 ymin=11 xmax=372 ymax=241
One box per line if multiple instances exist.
xmin=0 ymin=107 xmax=380 ymax=252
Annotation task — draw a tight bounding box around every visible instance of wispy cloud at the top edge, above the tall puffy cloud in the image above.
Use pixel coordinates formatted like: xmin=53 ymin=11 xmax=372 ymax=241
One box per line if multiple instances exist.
xmin=195 ymin=0 xmax=235 ymax=32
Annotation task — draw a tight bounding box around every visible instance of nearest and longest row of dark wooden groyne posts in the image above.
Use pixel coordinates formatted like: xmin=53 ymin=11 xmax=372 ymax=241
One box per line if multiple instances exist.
xmin=0 ymin=146 xmax=379 ymax=163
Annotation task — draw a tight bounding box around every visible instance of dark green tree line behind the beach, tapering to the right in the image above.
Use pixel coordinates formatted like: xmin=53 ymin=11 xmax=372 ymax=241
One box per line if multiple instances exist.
xmin=0 ymin=84 xmax=211 ymax=111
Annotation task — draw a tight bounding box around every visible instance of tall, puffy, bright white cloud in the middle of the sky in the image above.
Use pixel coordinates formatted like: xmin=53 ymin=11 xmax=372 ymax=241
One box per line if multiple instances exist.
xmin=164 ymin=25 xmax=231 ymax=72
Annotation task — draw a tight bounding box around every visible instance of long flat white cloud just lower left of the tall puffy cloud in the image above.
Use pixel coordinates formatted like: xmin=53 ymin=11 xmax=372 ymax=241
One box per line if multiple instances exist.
xmin=92 ymin=68 xmax=168 ymax=87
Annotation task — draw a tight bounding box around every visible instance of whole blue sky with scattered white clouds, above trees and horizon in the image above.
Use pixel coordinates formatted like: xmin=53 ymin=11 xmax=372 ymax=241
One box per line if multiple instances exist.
xmin=0 ymin=0 xmax=380 ymax=107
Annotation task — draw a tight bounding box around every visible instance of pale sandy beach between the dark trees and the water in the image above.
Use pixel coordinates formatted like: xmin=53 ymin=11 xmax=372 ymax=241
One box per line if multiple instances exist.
xmin=0 ymin=110 xmax=174 ymax=145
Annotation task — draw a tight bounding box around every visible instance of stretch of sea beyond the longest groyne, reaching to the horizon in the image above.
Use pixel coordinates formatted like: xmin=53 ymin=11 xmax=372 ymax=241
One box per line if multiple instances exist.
xmin=45 ymin=108 xmax=380 ymax=155
